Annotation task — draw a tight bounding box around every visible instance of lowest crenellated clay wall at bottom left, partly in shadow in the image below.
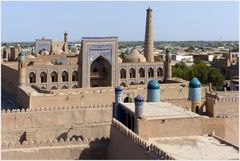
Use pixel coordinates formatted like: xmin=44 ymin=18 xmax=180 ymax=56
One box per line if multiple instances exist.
xmin=1 ymin=137 xmax=109 ymax=160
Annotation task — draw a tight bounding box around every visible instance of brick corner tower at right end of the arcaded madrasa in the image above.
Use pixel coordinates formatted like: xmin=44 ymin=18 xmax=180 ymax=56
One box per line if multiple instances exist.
xmin=164 ymin=48 xmax=172 ymax=81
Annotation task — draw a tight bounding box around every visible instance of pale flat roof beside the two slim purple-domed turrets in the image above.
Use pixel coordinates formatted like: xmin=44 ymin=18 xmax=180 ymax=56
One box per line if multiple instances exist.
xmin=121 ymin=102 xmax=201 ymax=119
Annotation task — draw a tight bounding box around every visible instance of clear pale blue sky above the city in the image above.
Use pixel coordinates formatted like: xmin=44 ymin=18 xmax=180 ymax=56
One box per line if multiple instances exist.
xmin=1 ymin=1 xmax=239 ymax=41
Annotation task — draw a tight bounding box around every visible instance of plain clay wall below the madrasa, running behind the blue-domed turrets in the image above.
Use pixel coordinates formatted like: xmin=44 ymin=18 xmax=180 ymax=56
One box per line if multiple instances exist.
xmin=24 ymin=83 xmax=205 ymax=108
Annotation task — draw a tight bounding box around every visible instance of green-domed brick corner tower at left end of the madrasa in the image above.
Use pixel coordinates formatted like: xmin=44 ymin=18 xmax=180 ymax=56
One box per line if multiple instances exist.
xmin=18 ymin=50 xmax=26 ymax=86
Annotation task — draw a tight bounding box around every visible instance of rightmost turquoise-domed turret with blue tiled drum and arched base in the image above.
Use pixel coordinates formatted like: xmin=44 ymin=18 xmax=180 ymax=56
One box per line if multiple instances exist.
xmin=188 ymin=77 xmax=202 ymax=113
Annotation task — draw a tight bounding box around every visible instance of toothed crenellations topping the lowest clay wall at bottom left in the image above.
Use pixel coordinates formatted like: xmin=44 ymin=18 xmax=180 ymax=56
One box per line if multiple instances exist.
xmin=1 ymin=137 xmax=109 ymax=150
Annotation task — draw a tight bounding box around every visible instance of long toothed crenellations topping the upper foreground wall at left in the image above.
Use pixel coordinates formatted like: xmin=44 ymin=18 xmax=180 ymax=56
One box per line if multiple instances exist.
xmin=1 ymin=104 xmax=112 ymax=114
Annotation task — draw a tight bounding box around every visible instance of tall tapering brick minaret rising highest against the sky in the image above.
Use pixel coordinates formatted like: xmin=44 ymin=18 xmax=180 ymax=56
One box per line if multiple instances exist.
xmin=144 ymin=7 xmax=154 ymax=62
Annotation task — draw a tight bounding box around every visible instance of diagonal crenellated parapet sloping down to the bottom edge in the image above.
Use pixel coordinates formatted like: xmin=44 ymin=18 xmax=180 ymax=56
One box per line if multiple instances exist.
xmin=112 ymin=118 xmax=175 ymax=160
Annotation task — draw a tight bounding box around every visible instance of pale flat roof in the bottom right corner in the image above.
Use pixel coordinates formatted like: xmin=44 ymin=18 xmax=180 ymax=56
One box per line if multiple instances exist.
xmin=149 ymin=136 xmax=239 ymax=160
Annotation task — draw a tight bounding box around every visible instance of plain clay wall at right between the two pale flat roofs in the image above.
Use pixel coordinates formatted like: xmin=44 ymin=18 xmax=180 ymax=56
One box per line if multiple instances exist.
xmin=139 ymin=117 xmax=236 ymax=145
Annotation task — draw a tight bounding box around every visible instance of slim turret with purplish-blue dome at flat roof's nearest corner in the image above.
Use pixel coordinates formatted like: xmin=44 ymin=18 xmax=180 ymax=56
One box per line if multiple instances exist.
xmin=134 ymin=95 xmax=144 ymax=134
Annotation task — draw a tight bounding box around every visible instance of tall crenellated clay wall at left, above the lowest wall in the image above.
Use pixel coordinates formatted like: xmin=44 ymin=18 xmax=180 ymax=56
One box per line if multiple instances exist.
xmin=1 ymin=105 xmax=112 ymax=141
